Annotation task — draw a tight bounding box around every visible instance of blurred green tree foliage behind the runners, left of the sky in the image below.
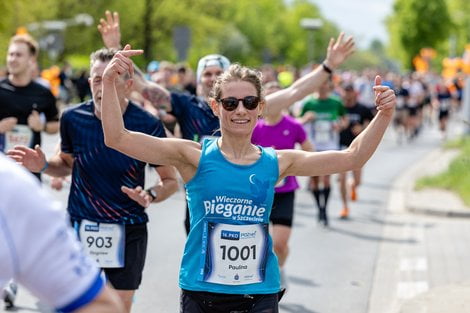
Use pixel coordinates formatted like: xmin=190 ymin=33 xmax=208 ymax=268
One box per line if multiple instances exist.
xmin=0 ymin=0 xmax=396 ymax=71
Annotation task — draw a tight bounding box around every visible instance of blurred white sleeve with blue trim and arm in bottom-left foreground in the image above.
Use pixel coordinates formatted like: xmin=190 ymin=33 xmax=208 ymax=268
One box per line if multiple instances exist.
xmin=0 ymin=157 xmax=123 ymax=312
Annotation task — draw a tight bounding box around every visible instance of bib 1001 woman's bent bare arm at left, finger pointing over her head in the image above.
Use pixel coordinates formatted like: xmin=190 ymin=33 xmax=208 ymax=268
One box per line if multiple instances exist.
xmin=101 ymin=45 xmax=200 ymax=179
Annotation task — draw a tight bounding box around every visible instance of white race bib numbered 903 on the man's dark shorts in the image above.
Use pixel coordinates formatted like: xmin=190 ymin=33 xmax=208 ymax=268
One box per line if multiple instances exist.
xmin=79 ymin=220 xmax=125 ymax=268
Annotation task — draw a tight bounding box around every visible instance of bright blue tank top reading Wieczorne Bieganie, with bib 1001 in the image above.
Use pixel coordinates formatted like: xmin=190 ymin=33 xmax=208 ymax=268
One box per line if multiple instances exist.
xmin=180 ymin=139 xmax=280 ymax=294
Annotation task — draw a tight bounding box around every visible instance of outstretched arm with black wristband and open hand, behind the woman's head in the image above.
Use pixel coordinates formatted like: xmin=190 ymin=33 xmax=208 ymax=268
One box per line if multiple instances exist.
xmin=263 ymin=33 xmax=354 ymax=116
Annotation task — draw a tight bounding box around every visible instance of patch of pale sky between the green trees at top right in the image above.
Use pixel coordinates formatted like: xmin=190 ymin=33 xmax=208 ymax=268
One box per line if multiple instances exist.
xmin=310 ymin=0 xmax=394 ymax=48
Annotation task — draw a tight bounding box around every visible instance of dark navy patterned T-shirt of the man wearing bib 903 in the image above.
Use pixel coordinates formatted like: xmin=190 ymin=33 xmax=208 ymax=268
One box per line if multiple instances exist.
xmin=60 ymin=100 xmax=166 ymax=224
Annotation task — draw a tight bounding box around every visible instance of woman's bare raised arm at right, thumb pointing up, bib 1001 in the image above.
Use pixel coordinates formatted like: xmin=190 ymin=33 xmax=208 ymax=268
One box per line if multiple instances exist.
xmin=278 ymin=76 xmax=396 ymax=178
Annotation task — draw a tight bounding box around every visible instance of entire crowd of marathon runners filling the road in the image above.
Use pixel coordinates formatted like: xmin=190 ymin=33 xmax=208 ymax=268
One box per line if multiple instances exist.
xmin=0 ymin=8 xmax=462 ymax=312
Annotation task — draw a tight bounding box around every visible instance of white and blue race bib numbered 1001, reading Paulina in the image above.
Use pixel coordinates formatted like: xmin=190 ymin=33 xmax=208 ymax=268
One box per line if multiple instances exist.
xmin=200 ymin=222 xmax=268 ymax=285
